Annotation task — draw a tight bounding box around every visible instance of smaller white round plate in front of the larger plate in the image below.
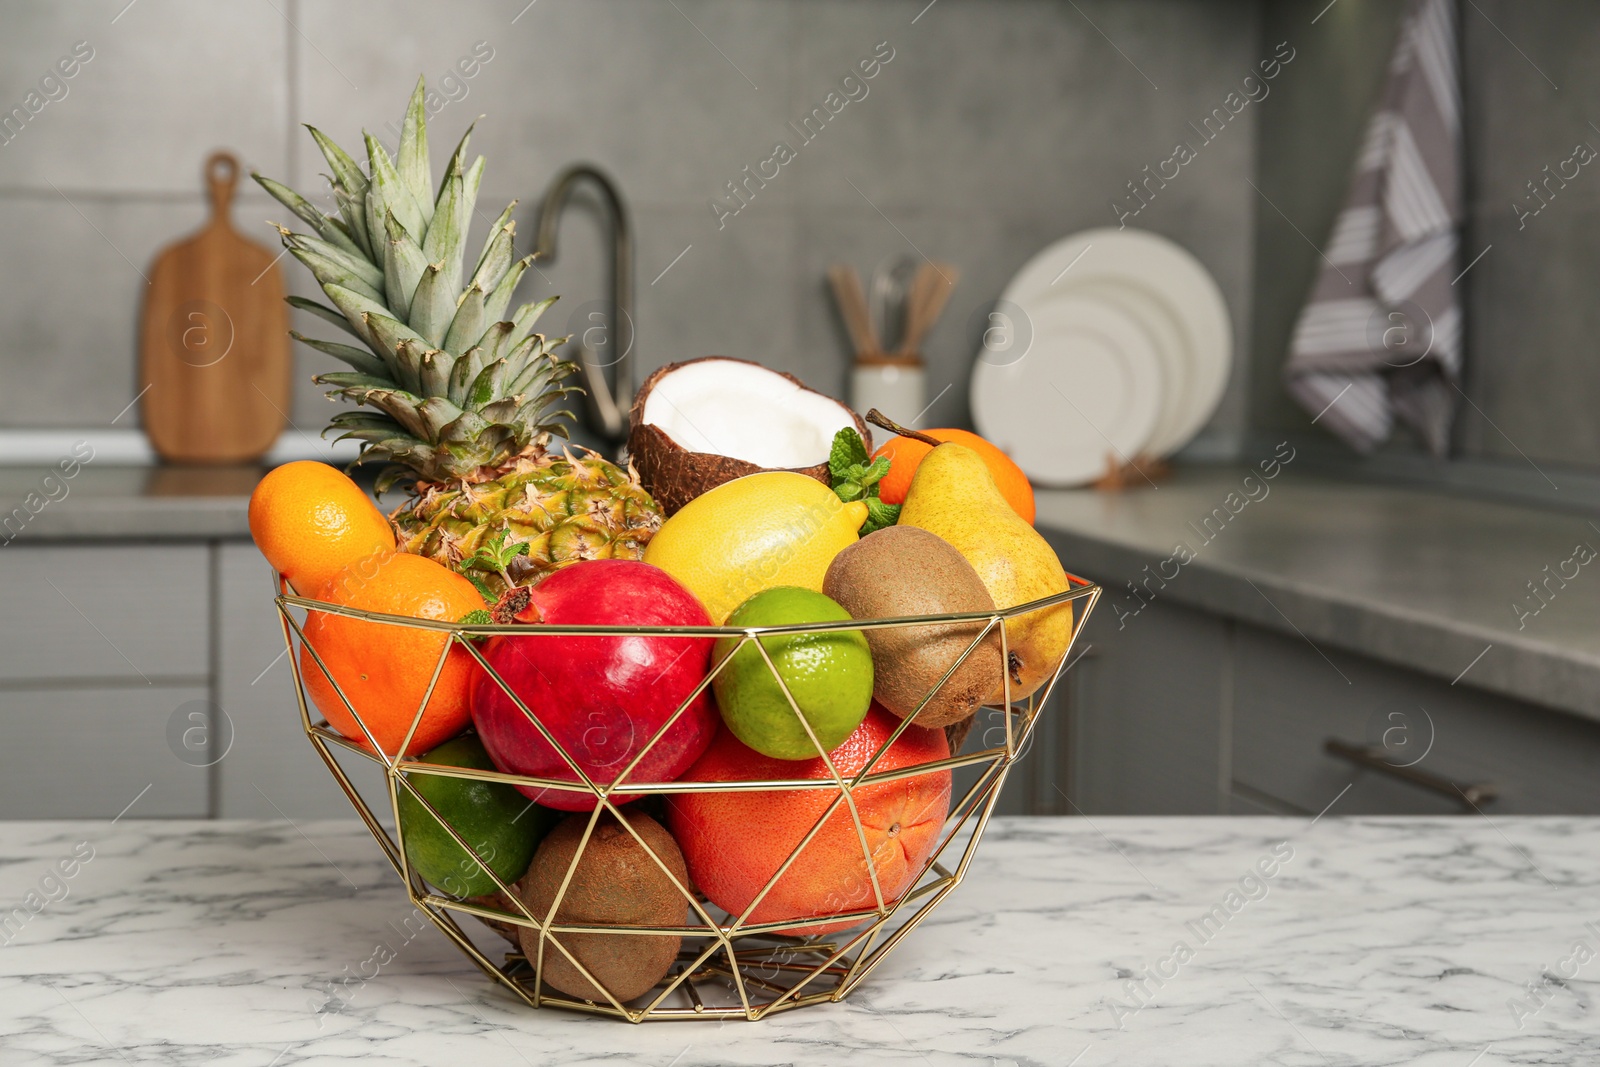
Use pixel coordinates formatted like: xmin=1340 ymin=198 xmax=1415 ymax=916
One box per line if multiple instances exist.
xmin=971 ymin=291 xmax=1162 ymax=486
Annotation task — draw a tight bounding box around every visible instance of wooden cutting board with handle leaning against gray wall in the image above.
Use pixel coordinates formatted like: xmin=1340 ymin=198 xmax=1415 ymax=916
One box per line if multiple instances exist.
xmin=139 ymin=152 xmax=293 ymax=462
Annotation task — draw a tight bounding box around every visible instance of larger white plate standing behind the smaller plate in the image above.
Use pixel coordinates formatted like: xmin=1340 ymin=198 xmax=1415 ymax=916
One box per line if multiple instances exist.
xmin=1002 ymin=227 xmax=1234 ymax=456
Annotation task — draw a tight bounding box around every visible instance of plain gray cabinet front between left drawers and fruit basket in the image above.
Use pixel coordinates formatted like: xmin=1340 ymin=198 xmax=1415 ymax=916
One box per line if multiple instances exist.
xmin=216 ymin=542 xmax=353 ymax=819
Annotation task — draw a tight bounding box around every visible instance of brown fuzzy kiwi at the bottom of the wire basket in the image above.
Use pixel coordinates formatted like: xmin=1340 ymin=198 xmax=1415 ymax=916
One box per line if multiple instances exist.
xmin=520 ymin=813 xmax=690 ymax=1003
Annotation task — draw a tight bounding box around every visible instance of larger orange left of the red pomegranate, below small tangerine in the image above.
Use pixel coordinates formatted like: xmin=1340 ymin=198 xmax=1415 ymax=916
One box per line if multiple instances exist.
xmin=301 ymin=552 xmax=483 ymax=755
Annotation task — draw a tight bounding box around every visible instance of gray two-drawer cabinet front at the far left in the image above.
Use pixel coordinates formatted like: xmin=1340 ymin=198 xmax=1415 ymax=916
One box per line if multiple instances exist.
xmin=0 ymin=544 xmax=211 ymax=819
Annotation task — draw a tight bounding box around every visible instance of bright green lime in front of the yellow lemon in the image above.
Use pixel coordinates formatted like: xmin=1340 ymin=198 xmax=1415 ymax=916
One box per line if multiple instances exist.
xmin=712 ymin=585 xmax=872 ymax=760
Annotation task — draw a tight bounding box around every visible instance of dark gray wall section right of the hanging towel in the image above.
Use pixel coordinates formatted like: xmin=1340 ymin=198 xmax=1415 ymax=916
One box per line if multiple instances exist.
xmin=1458 ymin=0 xmax=1600 ymax=467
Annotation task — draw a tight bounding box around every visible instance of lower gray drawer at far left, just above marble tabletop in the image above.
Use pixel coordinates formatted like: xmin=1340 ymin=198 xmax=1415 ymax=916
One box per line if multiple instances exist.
xmin=0 ymin=685 xmax=210 ymax=819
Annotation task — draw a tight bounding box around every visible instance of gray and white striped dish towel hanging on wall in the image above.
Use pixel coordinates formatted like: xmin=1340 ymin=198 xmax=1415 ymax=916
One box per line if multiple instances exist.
xmin=1285 ymin=0 xmax=1461 ymax=456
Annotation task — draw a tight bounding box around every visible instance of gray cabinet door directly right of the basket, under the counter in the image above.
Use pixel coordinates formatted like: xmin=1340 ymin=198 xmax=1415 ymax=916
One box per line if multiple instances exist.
xmin=1064 ymin=600 xmax=1232 ymax=814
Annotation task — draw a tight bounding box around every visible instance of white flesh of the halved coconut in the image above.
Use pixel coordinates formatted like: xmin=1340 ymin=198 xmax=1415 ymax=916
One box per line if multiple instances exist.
xmin=640 ymin=360 xmax=856 ymax=469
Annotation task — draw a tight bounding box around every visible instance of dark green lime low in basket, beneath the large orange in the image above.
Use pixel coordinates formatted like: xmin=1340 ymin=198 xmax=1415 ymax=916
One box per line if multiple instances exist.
xmin=397 ymin=734 xmax=560 ymax=897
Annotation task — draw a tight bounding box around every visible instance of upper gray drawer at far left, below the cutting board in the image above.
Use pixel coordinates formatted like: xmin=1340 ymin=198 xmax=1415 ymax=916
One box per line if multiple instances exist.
xmin=0 ymin=545 xmax=210 ymax=685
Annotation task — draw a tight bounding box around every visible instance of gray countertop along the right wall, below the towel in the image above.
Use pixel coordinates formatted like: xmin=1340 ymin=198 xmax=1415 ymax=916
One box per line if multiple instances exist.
xmin=1037 ymin=462 xmax=1600 ymax=720
